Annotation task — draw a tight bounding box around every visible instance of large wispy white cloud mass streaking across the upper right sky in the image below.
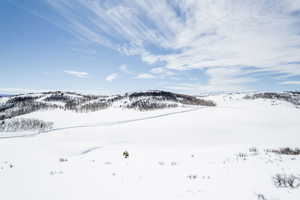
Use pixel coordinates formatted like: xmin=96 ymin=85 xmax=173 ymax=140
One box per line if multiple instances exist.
xmin=48 ymin=0 xmax=300 ymax=91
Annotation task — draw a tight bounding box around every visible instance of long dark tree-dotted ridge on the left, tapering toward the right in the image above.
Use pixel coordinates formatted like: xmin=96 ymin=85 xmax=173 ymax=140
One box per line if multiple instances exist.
xmin=0 ymin=90 xmax=216 ymax=120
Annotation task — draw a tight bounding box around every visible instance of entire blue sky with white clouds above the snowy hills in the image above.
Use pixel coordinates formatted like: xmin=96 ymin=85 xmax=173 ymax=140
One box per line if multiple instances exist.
xmin=0 ymin=0 xmax=300 ymax=94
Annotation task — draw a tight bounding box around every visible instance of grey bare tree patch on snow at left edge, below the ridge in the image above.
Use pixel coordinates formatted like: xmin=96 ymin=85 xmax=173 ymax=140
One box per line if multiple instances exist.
xmin=0 ymin=118 xmax=53 ymax=132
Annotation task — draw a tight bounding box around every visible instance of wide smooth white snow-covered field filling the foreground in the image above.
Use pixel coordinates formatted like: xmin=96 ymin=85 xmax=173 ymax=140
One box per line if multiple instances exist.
xmin=0 ymin=95 xmax=300 ymax=200
